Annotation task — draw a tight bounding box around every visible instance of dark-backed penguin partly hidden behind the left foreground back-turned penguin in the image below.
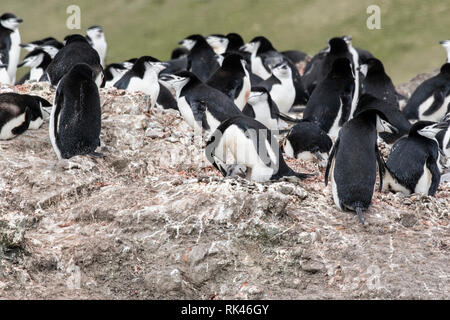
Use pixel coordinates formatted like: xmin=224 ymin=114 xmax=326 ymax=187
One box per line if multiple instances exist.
xmin=46 ymin=34 xmax=103 ymax=87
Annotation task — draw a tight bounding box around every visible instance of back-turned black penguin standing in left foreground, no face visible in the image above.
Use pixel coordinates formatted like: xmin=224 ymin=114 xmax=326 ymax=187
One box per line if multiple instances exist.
xmin=49 ymin=63 xmax=101 ymax=159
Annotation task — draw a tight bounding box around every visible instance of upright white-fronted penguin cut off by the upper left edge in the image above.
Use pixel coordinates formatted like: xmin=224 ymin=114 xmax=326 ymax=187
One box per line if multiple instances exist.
xmin=0 ymin=13 xmax=23 ymax=84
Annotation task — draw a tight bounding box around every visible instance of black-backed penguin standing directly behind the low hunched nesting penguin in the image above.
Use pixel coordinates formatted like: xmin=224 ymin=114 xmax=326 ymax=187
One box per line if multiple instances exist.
xmin=303 ymin=58 xmax=355 ymax=138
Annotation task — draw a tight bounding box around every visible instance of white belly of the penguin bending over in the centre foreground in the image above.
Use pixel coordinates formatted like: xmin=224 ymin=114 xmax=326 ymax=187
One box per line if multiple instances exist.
xmin=223 ymin=125 xmax=274 ymax=181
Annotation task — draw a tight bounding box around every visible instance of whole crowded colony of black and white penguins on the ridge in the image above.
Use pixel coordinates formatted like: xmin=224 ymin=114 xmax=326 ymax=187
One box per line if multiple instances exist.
xmin=0 ymin=13 xmax=450 ymax=224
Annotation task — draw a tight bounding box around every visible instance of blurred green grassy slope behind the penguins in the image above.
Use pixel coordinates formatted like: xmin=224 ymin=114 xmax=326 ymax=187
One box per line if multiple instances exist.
xmin=2 ymin=0 xmax=450 ymax=83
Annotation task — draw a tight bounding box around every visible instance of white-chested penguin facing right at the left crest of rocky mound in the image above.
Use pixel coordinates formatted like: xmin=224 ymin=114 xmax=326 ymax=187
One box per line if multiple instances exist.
xmin=114 ymin=56 xmax=166 ymax=107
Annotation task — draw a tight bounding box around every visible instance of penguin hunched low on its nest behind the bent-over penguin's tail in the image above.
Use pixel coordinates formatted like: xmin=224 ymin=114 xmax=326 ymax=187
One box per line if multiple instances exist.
xmin=283 ymin=121 xmax=333 ymax=166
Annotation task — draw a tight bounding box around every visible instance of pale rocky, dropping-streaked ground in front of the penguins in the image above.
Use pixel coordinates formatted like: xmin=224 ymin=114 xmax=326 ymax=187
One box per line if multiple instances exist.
xmin=0 ymin=78 xmax=450 ymax=299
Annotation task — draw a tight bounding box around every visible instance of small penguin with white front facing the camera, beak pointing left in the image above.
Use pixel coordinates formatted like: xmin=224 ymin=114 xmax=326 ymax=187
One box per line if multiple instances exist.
xmin=258 ymin=61 xmax=295 ymax=113
